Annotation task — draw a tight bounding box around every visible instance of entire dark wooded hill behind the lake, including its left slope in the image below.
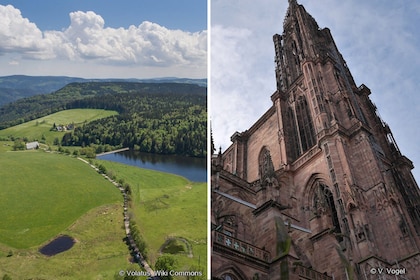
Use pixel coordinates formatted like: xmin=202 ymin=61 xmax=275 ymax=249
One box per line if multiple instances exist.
xmin=0 ymin=82 xmax=207 ymax=157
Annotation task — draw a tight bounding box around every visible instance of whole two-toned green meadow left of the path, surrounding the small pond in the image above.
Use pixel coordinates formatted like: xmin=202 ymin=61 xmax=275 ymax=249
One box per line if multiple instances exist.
xmin=0 ymin=145 xmax=130 ymax=279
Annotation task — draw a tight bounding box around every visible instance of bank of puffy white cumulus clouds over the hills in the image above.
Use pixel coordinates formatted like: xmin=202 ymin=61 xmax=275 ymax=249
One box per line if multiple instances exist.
xmin=0 ymin=5 xmax=207 ymax=67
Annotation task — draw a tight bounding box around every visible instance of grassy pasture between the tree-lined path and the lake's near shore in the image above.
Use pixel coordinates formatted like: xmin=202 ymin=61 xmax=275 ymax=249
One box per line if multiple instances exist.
xmin=94 ymin=160 xmax=207 ymax=276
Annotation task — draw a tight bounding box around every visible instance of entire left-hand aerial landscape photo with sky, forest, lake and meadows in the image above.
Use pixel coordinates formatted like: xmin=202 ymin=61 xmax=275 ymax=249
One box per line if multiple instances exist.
xmin=0 ymin=1 xmax=208 ymax=279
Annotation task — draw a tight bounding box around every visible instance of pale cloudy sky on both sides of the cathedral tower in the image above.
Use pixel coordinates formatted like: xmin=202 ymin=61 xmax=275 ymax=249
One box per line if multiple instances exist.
xmin=210 ymin=0 xmax=420 ymax=182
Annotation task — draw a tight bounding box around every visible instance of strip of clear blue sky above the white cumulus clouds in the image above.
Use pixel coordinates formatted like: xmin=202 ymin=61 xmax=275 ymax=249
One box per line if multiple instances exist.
xmin=0 ymin=0 xmax=207 ymax=32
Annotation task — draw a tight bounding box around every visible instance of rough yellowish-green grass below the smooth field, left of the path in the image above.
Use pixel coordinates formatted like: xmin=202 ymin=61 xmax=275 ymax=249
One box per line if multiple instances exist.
xmin=0 ymin=204 xmax=130 ymax=280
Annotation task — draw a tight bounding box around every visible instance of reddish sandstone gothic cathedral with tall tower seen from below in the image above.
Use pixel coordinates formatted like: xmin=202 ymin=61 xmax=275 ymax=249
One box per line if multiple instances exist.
xmin=211 ymin=0 xmax=420 ymax=280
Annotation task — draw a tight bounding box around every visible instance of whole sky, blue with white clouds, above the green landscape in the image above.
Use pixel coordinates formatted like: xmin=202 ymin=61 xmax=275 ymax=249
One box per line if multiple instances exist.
xmin=0 ymin=0 xmax=207 ymax=78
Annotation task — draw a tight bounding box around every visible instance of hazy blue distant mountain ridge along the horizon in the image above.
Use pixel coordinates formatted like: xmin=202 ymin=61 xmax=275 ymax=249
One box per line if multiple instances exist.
xmin=0 ymin=75 xmax=207 ymax=107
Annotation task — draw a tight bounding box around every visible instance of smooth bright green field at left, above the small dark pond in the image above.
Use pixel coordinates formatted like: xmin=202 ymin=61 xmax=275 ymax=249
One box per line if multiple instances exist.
xmin=0 ymin=150 xmax=122 ymax=249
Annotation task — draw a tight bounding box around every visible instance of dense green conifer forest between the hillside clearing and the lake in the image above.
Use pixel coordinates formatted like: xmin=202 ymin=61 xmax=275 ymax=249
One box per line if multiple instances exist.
xmin=61 ymin=93 xmax=207 ymax=157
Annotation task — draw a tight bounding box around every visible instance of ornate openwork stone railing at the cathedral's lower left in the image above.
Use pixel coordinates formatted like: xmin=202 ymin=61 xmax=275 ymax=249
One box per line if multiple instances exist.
xmin=215 ymin=232 xmax=271 ymax=262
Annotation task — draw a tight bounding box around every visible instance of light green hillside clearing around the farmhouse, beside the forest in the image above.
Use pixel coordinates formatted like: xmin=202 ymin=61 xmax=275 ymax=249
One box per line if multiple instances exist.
xmin=0 ymin=109 xmax=118 ymax=145
